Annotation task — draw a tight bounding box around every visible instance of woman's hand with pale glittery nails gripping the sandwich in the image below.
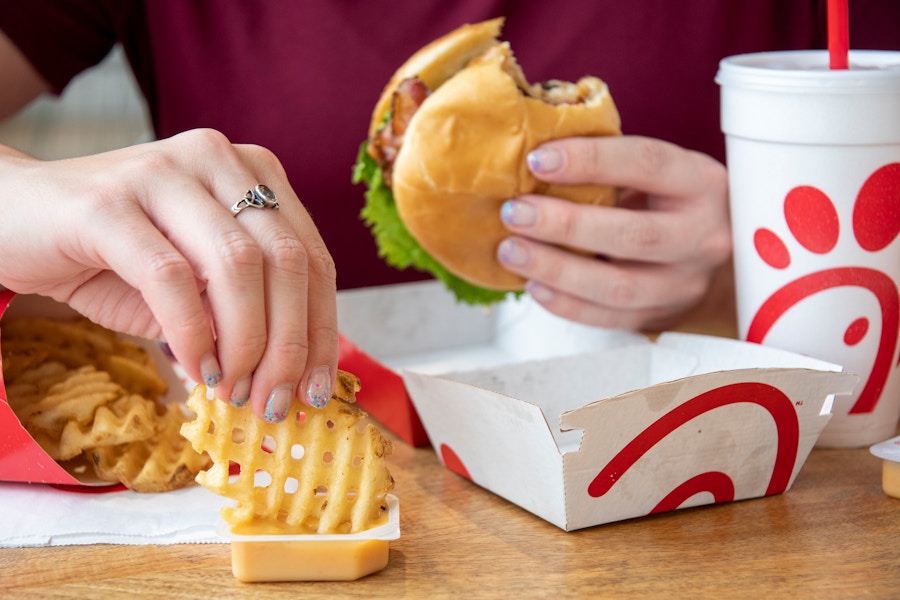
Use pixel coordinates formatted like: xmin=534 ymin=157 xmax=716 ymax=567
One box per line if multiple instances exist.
xmin=497 ymin=136 xmax=731 ymax=329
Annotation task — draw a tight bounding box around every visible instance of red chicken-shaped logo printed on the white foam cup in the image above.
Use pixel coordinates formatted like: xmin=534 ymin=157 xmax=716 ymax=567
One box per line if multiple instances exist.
xmin=746 ymin=163 xmax=900 ymax=413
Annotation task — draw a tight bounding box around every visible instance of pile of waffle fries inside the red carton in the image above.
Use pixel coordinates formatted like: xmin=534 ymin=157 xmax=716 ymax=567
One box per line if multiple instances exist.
xmin=0 ymin=318 xmax=211 ymax=492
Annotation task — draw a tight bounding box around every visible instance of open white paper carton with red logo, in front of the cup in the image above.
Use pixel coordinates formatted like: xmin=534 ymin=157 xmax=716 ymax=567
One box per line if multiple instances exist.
xmin=339 ymin=284 xmax=859 ymax=530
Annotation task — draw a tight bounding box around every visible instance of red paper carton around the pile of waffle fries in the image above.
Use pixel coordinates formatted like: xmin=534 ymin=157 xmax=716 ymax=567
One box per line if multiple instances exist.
xmin=0 ymin=290 xmax=187 ymax=486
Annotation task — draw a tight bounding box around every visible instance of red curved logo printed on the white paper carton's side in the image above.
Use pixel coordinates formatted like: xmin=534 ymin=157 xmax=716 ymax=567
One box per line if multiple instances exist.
xmin=587 ymin=382 xmax=800 ymax=514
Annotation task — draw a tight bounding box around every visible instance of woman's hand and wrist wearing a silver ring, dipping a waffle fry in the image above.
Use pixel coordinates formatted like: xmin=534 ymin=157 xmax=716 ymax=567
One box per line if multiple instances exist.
xmin=0 ymin=130 xmax=338 ymax=422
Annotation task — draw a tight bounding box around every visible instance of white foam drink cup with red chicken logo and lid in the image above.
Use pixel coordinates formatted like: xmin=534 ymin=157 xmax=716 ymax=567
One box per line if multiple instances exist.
xmin=716 ymin=50 xmax=900 ymax=447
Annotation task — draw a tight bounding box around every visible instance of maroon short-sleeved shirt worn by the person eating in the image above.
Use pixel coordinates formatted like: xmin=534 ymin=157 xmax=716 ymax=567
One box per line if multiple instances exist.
xmin=0 ymin=0 xmax=900 ymax=288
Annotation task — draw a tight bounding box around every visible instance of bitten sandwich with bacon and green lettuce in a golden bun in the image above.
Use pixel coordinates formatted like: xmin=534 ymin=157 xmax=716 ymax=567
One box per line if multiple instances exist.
xmin=353 ymin=18 xmax=621 ymax=304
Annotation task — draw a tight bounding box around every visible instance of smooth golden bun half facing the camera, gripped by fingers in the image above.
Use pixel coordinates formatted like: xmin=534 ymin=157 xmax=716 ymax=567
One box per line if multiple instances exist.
xmin=390 ymin=37 xmax=620 ymax=290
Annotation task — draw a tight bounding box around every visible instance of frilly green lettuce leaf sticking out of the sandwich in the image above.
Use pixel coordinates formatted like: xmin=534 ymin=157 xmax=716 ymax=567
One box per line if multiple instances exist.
xmin=353 ymin=142 xmax=521 ymax=305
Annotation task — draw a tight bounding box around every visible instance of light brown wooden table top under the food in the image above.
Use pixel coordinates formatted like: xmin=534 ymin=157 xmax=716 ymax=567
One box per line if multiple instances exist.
xmin=0 ymin=426 xmax=900 ymax=600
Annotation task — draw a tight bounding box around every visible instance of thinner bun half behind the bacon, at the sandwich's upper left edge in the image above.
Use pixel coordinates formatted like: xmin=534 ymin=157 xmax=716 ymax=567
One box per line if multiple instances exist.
xmin=369 ymin=17 xmax=504 ymax=137
